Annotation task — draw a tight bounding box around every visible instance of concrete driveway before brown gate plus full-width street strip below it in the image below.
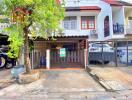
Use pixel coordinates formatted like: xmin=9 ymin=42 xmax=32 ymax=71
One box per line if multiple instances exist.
xmin=0 ymin=69 xmax=132 ymax=100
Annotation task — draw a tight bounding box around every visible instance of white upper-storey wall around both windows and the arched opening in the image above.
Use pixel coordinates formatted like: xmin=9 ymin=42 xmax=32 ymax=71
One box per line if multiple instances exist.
xmin=61 ymin=0 xmax=113 ymax=41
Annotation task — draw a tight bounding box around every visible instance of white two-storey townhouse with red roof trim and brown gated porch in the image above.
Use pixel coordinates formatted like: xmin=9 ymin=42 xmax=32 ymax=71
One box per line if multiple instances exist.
xmin=0 ymin=0 xmax=132 ymax=69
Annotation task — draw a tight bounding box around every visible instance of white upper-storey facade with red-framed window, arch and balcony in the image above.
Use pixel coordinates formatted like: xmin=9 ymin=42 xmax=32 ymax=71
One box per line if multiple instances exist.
xmin=61 ymin=0 xmax=132 ymax=41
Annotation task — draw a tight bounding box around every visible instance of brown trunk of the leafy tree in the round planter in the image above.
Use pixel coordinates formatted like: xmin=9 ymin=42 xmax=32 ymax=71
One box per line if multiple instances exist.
xmin=23 ymin=27 xmax=31 ymax=73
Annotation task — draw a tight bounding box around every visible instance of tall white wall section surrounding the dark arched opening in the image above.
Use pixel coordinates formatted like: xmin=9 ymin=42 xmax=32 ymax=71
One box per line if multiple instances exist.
xmin=97 ymin=1 xmax=113 ymax=41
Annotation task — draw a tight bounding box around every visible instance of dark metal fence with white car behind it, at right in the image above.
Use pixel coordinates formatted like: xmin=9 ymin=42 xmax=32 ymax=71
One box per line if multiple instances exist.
xmin=88 ymin=41 xmax=132 ymax=67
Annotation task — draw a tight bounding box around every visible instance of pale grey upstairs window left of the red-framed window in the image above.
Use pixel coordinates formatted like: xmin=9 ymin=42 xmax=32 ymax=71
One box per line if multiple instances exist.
xmin=63 ymin=16 xmax=77 ymax=30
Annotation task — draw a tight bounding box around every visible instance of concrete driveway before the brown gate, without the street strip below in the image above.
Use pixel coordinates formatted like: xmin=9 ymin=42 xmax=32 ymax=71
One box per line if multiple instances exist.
xmin=0 ymin=70 xmax=105 ymax=96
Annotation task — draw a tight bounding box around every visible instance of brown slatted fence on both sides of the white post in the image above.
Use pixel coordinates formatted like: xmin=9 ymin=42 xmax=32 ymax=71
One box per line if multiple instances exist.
xmin=30 ymin=49 xmax=85 ymax=68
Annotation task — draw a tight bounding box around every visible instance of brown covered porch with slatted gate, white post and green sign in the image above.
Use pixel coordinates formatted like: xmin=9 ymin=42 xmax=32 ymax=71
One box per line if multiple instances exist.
xmin=32 ymin=36 xmax=88 ymax=69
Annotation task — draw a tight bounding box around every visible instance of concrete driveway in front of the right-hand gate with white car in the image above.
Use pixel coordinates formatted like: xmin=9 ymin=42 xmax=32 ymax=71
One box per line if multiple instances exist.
xmin=90 ymin=67 xmax=132 ymax=91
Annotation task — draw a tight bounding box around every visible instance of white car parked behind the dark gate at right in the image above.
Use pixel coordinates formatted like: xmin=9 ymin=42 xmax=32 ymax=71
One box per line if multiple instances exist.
xmin=89 ymin=43 xmax=115 ymax=64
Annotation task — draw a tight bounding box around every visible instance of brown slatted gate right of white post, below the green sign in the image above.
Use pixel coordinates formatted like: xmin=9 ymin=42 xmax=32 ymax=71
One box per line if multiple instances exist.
xmin=50 ymin=49 xmax=84 ymax=67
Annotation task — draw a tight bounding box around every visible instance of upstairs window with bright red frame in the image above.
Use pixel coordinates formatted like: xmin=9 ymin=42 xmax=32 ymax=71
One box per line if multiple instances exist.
xmin=81 ymin=16 xmax=95 ymax=29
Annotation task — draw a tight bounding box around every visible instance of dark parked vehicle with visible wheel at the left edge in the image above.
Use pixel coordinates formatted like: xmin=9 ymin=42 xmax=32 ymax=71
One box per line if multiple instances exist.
xmin=0 ymin=48 xmax=16 ymax=69
